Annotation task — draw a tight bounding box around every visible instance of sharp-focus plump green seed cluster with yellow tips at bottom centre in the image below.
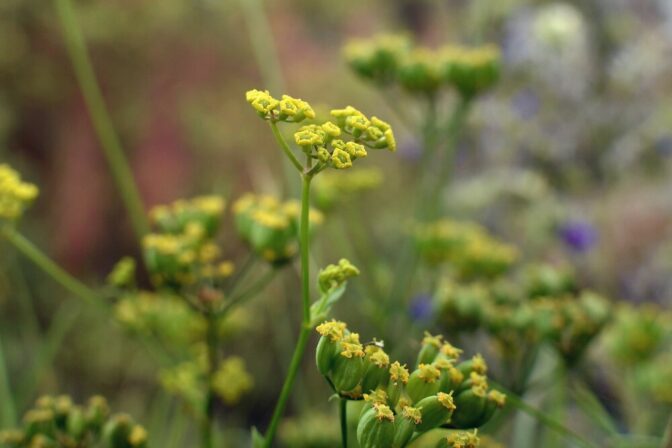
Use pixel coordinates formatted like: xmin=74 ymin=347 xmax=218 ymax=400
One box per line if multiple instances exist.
xmin=316 ymin=321 xmax=506 ymax=448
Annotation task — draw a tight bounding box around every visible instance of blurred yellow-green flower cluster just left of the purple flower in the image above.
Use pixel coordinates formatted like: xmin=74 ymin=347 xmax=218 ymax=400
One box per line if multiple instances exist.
xmin=415 ymin=219 xmax=518 ymax=278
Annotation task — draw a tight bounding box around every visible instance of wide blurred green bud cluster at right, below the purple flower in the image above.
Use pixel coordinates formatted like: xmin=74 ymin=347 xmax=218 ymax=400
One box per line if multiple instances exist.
xmin=436 ymin=265 xmax=611 ymax=360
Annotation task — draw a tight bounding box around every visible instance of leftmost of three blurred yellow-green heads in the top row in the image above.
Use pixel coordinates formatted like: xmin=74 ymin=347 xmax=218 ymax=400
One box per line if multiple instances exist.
xmin=343 ymin=34 xmax=411 ymax=85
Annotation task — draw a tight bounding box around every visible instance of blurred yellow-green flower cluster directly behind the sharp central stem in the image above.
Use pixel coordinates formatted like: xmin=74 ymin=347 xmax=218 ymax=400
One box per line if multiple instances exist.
xmin=233 ymin=193 xmax=324 ymax=264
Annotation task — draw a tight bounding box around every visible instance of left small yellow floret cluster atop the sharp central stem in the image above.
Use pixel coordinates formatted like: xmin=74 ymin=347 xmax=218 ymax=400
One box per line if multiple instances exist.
xmin=245 ymin=89 xmax=315 ymax=123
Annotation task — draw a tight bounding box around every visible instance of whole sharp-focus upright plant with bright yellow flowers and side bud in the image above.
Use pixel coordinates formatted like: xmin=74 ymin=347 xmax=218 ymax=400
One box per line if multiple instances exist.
xmin=246 ymin=90 xmax=397 ymax=447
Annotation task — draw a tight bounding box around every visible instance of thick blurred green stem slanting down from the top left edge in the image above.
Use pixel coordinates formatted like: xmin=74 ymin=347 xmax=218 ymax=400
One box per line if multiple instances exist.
xmin=54 ymin=0 xmax=149 ymax=239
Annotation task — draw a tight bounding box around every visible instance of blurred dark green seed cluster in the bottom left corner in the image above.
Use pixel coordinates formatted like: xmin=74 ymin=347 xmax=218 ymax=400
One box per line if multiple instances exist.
xmin=0 ymin=395 xmax=148 ymax=448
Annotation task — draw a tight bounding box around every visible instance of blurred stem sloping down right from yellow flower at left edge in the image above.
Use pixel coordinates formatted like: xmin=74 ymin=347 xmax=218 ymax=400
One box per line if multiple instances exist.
xmin=0 ymin=226 xmax=97 ymax=303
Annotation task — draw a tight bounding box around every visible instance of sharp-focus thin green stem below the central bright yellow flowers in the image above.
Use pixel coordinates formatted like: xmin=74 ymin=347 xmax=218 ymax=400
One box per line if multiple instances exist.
xmin=264 ymin=175 xmax=312 ymax=448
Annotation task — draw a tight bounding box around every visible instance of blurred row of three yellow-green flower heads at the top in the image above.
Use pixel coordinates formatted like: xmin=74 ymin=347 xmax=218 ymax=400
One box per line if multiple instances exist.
xmin=344 ymin=35 xmax=501 ymax=98
